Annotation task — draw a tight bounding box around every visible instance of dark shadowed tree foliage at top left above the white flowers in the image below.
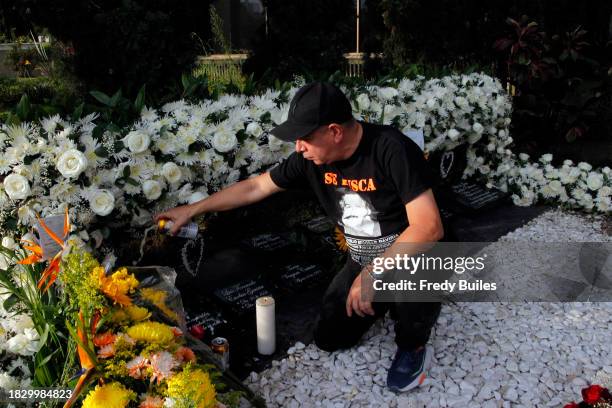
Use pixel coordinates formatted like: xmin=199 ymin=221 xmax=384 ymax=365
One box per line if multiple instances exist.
xmin=15 ymin=0 xmax=210 ymax=101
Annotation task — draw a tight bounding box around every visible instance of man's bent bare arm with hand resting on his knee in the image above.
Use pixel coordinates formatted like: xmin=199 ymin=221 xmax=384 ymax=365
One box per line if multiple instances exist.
xmin=346 ymin=189 xmax=444 ymax=317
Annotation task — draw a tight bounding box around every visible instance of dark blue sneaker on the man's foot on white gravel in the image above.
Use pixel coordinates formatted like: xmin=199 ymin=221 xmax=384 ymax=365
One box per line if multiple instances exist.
xmin=387 ymin=346 xmax=433 ymax=392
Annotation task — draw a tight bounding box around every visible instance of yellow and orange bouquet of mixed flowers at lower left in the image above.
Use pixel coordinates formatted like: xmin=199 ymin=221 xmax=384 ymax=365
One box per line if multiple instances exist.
xmin=59 ymin=248 xmax=235 ymax=408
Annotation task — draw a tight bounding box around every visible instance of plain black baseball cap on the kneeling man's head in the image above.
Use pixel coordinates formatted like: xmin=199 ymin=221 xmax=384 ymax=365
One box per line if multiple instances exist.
xmin=270 ymin=82 xmax=353 ymax=142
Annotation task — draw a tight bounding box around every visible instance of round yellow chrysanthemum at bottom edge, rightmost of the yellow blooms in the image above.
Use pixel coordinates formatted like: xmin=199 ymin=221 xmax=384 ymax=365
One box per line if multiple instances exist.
xmin=167 ymin=365 xmax=216 ymax=408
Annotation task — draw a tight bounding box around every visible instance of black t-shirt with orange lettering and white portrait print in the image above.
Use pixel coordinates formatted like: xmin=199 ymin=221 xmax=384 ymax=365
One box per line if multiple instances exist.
xmin=270 ymin=123 xmax=433 ymax=265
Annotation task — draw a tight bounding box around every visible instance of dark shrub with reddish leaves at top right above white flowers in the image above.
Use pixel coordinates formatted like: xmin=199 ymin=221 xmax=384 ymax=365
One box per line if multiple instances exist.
xmin=495 ymin=16 xmax=612 ymax=150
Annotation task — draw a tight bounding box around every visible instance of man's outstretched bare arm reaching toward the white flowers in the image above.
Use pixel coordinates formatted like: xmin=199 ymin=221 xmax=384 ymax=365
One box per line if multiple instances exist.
xmin=154 ymin=173 xmax=283 ymax=235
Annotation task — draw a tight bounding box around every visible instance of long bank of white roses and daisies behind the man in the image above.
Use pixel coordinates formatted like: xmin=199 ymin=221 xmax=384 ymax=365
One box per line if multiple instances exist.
xmin=0 ymin=73 xmax=611 ymax=252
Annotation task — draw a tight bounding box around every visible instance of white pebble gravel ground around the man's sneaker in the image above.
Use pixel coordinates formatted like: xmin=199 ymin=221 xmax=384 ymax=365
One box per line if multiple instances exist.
xmin=246 ymin=210 xmax=612 ymax=408
